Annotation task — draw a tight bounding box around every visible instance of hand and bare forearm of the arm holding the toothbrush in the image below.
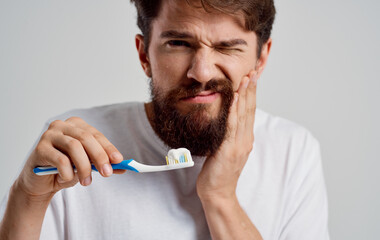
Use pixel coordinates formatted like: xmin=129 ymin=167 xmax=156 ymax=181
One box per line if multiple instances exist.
xmin=0 ymin=117 xmax=124 ymax=240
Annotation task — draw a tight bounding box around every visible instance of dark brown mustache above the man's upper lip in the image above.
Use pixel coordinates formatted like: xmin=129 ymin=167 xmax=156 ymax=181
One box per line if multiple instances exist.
xmin=167 ymin=78 xmax=233 ymax=101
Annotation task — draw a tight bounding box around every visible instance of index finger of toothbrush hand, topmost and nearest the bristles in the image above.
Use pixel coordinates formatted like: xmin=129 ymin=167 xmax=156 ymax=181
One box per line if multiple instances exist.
xmin=66 ymin=117 xmax=124 ymax=163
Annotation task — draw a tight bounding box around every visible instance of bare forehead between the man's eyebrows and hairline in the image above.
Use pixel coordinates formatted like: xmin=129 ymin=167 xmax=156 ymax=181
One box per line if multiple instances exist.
xmin=152 ymin=0 xmax=252 ymax=38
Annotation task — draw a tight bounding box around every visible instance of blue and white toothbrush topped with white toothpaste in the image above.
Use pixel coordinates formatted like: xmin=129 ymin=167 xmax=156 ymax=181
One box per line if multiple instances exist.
xmin=33 ymin=148 xmax=194 ymax=175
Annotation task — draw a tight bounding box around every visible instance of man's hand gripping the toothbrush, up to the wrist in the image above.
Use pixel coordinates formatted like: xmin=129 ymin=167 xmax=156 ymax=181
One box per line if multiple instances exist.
xmin=16 ymin=117 xmax=125 ymax=198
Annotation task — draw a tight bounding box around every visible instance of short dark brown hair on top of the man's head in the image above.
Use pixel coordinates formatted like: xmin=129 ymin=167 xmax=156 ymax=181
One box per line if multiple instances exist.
xmin=131 ymin=0 xmax=276 ymax=57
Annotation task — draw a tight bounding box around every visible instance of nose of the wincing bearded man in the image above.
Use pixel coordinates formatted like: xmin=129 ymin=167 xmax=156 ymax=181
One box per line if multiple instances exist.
xmin=187 ymin=49 xmax=218 ymax=83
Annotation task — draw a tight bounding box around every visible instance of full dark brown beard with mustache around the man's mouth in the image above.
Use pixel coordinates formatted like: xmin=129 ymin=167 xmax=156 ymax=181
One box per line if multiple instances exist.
xmin=150 ymin=79 xmax=234 ymax=156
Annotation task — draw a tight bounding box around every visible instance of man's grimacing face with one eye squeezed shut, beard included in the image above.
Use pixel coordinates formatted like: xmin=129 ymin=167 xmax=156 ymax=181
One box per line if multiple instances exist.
xmin=136 ymin=0 xmax=268 ymax=155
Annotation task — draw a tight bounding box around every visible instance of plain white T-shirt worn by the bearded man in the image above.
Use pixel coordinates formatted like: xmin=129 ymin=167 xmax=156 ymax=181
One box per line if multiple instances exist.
xmin=0 ymin=103 xmax=329 ymax=240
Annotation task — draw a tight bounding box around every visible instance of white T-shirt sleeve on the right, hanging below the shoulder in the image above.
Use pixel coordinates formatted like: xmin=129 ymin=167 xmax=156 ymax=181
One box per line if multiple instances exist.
xmin=279 ymin=133 xmax=329 ymax=240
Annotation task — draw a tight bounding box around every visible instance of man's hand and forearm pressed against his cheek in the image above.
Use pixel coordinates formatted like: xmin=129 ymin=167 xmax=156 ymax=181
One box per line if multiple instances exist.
xmin=197 ymin=73 xmax=262 ymax=240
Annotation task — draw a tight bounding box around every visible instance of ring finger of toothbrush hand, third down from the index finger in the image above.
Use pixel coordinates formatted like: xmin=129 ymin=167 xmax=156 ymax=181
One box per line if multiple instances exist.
xmin=52 ymin=135 xmax=92 ymax=186
